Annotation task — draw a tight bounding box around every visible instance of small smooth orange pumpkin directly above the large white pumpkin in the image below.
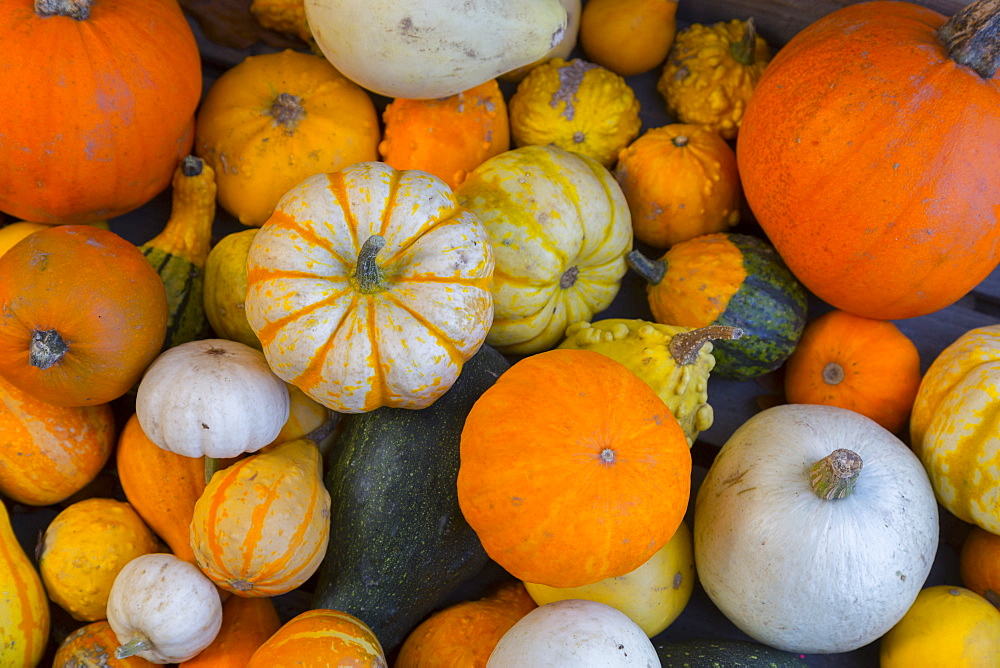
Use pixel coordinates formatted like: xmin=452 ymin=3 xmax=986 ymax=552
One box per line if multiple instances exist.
xmin=785 ymin=310 xmax=921 ymax=433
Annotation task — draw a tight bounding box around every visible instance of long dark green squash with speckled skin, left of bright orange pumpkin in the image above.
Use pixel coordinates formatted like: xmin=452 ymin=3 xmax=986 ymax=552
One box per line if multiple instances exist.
xmin=312 ymin=345 xmax=508 ymax=652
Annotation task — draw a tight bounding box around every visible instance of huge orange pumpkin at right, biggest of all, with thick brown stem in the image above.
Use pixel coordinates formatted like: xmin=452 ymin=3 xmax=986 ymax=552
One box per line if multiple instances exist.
xmin=736 ymin=0 xmax=1000 ymax=319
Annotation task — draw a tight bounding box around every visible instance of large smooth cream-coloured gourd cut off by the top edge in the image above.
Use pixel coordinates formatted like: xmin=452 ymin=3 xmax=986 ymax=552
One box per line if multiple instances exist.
xmin=305 ymin=0 xmax=567 ymax=98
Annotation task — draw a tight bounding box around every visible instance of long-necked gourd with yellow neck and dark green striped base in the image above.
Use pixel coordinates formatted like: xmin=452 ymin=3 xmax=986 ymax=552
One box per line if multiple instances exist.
xmin=139 ymin=155 xmax=216 ymax=350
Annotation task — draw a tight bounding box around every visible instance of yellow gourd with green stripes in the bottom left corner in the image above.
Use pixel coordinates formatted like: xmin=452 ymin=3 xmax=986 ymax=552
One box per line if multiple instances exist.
xmin=0 ymin=500 xmax=49 ymax=668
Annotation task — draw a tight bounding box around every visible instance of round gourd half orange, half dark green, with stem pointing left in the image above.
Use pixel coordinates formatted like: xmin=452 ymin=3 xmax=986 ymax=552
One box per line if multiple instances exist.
xmin=627 ymin=232 xmax=807 ymax=381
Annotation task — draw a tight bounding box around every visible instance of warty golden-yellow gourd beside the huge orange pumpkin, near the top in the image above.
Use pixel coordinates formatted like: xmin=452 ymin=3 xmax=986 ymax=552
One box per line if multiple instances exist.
xmin=656 ymin=19 xmax=771 ymax=139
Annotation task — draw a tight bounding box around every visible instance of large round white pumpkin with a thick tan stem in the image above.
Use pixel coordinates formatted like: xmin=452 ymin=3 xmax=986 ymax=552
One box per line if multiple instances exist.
xmin=694 ymin=405 xmax=938 ymax=654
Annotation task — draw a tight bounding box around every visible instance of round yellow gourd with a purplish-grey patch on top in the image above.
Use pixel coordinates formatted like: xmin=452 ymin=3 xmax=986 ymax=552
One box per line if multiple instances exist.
xmin=508 ymin=58 xmax=642 ymax=168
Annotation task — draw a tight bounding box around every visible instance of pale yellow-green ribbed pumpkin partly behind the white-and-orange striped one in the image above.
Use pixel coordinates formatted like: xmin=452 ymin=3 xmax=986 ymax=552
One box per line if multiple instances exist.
xmin=455 ymin=146 xmax=632 ymax=355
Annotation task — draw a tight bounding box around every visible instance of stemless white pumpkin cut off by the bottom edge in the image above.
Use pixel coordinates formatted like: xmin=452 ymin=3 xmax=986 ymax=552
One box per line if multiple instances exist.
xmin=486 ymin=599 xmax=660 ymax=668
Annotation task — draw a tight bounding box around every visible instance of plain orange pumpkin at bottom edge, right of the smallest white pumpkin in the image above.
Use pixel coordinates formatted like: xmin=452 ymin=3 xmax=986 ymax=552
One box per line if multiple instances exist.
xmin=179 ymin=596 xmax=281 ymax=668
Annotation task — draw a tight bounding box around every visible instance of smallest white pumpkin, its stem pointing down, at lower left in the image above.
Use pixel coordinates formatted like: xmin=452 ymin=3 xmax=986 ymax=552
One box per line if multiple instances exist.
xmin=107 ymin=553 xmax=222 ymax=664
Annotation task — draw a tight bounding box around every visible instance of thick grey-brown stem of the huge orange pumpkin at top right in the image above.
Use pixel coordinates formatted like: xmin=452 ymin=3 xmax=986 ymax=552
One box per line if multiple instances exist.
xmin=937 ymin=0 xmax=1000 ymax=79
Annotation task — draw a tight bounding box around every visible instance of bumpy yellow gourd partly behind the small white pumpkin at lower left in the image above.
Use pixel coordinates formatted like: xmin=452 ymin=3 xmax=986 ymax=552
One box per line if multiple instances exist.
xmin=38 ymin=498 xmax=159 ymax=622
